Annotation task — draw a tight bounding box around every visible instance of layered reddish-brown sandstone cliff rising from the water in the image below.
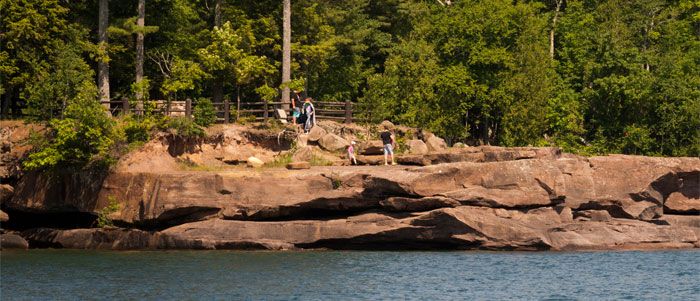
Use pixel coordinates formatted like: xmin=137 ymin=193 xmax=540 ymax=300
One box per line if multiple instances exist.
xmin=5 ymin=147 xmax=700 ymax=250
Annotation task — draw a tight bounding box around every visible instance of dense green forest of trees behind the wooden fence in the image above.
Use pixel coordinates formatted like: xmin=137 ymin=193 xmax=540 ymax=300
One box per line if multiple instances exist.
xmin=0 ymin=0 xmax=700 ymax=165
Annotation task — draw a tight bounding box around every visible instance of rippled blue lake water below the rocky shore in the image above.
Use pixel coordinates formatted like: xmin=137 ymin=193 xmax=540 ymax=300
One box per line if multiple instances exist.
xmin=0 ymin=250 xmax=700 ymax=300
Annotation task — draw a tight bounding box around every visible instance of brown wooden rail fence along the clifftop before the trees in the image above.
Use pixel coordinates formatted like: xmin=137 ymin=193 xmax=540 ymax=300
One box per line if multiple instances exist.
xmin=102 ymin=99 xmax=353 ymax=123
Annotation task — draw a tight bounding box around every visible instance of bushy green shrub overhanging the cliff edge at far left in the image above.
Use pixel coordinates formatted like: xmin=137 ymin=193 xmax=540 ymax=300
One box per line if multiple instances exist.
xmin=24 ymin=83 xmax=115 ymax=169
